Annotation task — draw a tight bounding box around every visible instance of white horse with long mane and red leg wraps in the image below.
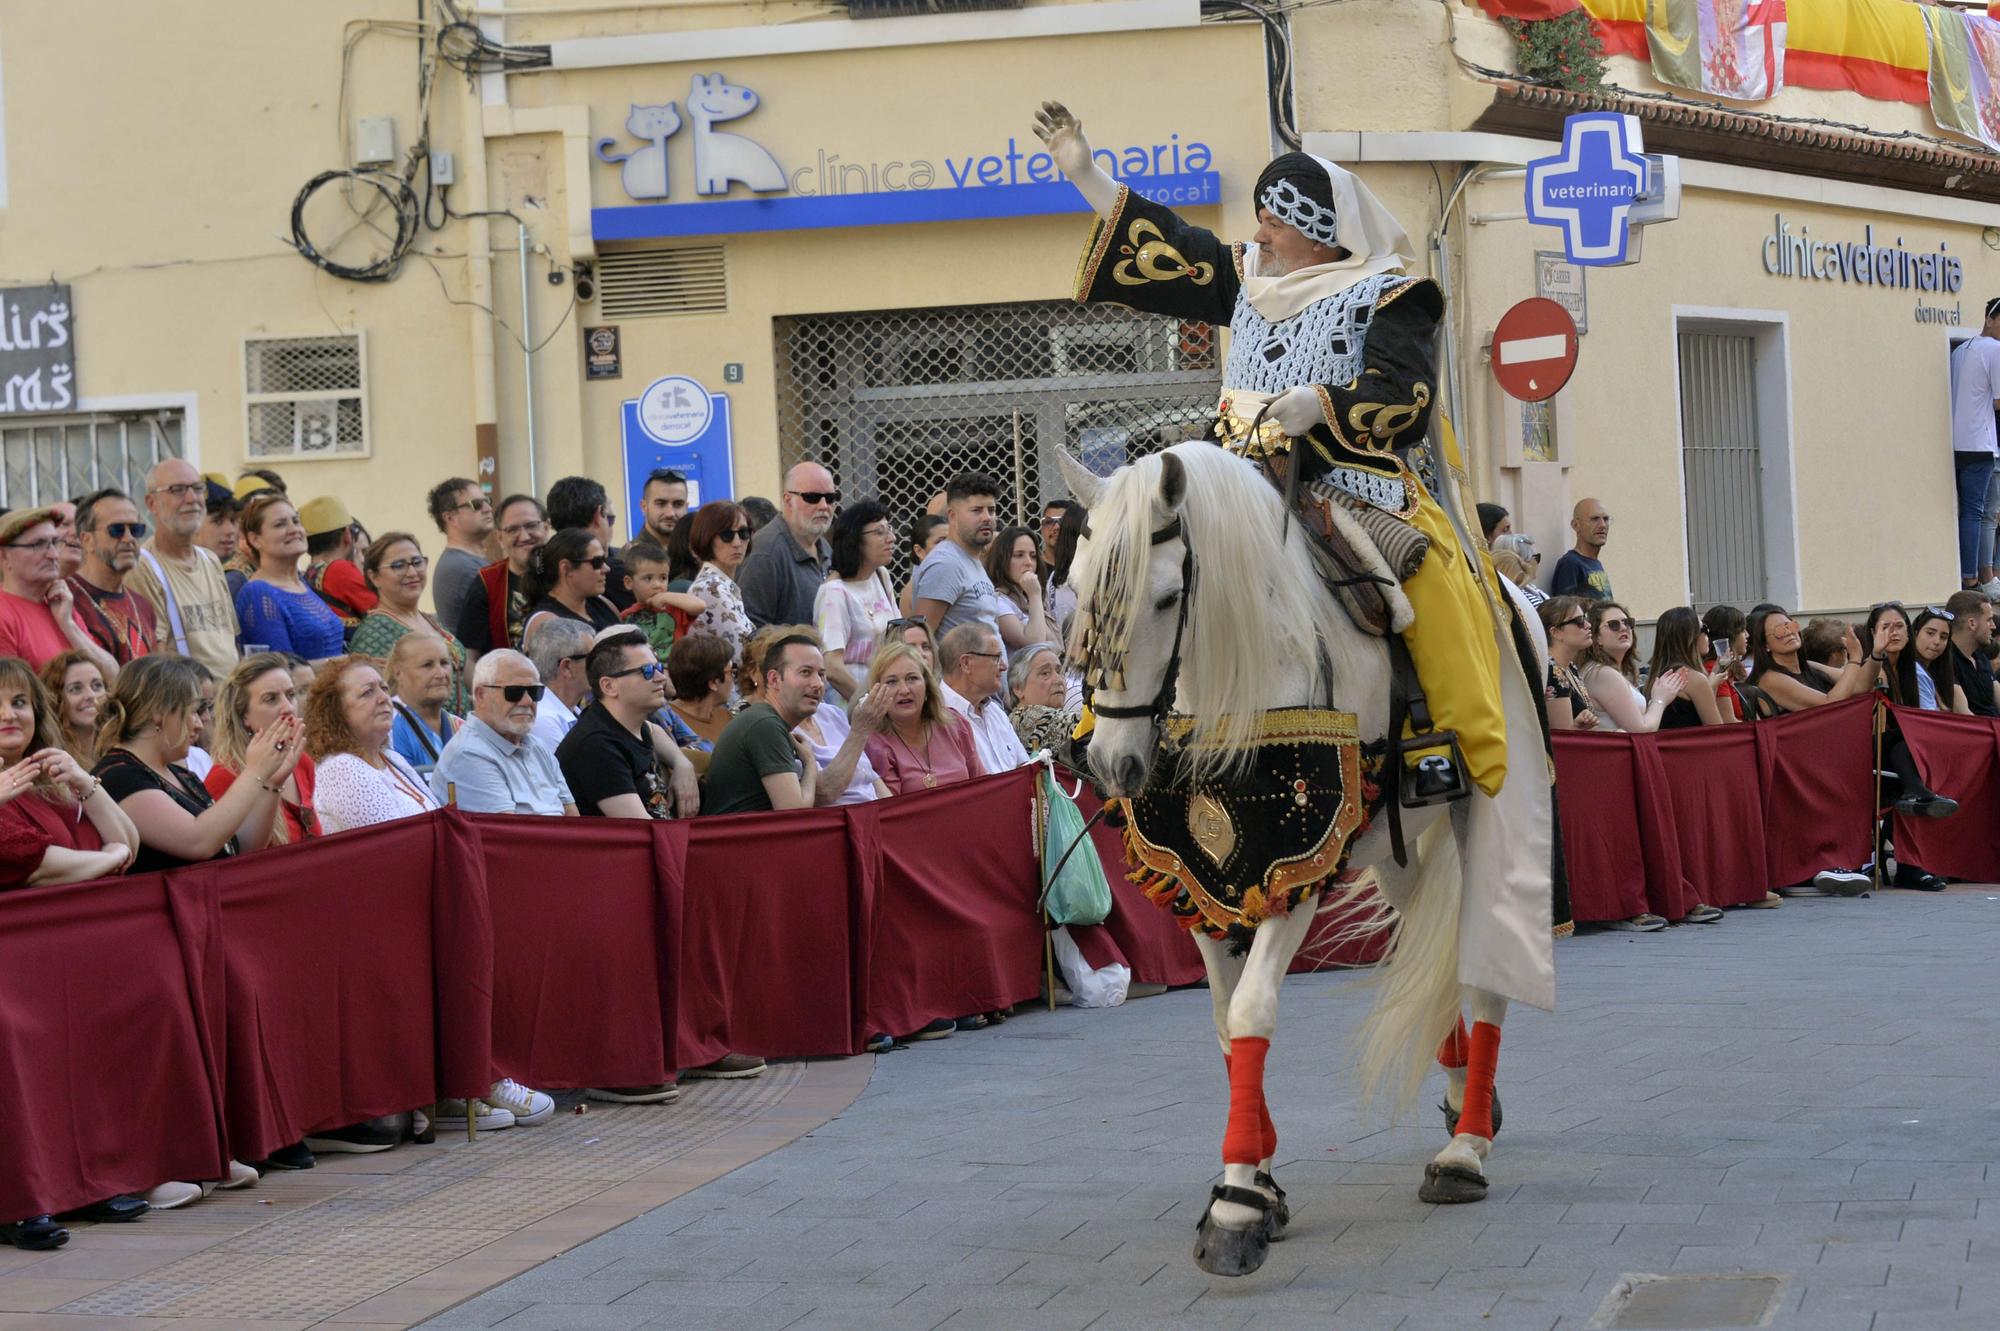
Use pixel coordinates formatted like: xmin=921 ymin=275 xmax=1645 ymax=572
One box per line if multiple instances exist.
xmin=1062 ymin=442 xmax=1554 ymax=1275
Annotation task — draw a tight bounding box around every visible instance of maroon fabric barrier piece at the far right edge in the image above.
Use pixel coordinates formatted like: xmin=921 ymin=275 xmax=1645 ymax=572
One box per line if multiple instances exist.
xmin=1890 ymin=707 xmax=2000 ymax=883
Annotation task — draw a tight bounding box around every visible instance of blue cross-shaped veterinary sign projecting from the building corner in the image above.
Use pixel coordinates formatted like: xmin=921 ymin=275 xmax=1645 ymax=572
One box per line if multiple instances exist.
xmin=1528 ymin=112 xmax=1646 ymax=266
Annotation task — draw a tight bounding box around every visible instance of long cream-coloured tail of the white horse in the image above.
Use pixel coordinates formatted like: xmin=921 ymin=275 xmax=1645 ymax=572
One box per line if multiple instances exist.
xmin=1322 ymin=817 xmax=1464 ymax=1113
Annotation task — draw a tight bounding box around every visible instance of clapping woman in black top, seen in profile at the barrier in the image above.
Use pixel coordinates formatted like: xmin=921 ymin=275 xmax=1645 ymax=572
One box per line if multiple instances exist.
xmin=96 ymin=656 xmax=302 ymax=873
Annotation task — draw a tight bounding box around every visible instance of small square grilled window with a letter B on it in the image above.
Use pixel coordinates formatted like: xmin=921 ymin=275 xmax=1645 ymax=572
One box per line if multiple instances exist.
xmin=244 ymin=334 xmax=368 ymax=460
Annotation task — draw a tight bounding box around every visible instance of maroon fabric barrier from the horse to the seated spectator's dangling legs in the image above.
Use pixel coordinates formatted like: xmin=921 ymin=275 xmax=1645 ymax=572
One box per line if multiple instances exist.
xmin=1556 ymin=697 xmax=1874 ymax=923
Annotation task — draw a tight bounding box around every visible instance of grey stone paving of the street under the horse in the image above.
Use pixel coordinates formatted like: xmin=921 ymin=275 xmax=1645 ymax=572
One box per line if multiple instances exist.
xmin=426 ymin=887 xmax=2000 ymax=1331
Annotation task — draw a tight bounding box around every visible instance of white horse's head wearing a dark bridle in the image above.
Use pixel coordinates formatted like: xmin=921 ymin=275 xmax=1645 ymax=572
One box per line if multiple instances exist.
xmin=1058 ymin=452 xmax=1194 ymax=795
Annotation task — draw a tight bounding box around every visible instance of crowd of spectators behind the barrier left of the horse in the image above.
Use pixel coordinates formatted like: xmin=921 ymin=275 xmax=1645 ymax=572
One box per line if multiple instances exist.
xmin=0 ymin=458 xmax=1078 ymax=1247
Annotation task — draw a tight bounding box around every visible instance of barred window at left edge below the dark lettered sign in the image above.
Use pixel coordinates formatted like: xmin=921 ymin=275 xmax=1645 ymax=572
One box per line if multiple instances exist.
xmin=0 ymin=408 xmax=184 ymax=508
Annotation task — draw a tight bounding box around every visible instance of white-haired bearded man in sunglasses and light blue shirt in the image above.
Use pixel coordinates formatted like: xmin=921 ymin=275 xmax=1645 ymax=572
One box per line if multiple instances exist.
xmin=430 ymin=648 xmax=576 ymax=817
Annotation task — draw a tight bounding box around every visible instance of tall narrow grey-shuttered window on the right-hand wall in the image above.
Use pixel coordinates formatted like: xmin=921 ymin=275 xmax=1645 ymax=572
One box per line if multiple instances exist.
xmin=1680 ymin=330 xmax=1766 ymax=610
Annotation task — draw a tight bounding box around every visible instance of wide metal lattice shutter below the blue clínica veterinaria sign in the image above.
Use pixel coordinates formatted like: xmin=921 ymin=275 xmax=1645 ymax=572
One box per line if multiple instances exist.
xmin=774 ymin=300 xmax=1222 ymax=578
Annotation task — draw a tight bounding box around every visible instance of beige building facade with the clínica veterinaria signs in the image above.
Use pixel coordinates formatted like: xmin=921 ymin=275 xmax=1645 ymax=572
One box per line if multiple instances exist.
xmin=0 ymin=0 xmax=2000 ymax=620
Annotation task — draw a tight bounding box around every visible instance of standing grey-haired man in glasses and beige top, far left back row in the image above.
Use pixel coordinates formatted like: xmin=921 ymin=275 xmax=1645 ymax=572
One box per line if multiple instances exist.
xmin=127 ymin=458 xmax=236 ymax=683
